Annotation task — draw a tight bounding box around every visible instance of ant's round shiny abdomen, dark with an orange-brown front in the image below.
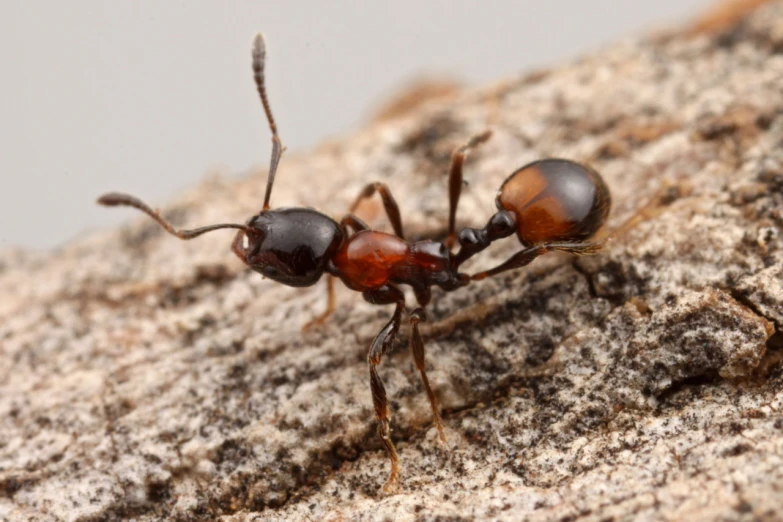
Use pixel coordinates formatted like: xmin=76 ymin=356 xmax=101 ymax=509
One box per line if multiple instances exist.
xmin=496 ymin=159 xmax=611 ymax=246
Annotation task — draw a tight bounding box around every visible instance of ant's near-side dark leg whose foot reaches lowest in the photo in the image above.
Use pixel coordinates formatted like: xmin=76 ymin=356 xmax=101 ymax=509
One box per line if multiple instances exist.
xmin=362 ymin=285 xmax=405 ymax=492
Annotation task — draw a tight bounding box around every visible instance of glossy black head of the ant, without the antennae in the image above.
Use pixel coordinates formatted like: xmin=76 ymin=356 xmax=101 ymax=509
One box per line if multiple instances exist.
xmin=234 ymin=208 xmax=343 ymax=286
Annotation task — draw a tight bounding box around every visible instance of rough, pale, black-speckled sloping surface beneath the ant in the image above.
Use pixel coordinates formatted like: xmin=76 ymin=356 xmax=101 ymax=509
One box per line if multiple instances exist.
xmin=0 ymin=2 xmax=783 ymax=522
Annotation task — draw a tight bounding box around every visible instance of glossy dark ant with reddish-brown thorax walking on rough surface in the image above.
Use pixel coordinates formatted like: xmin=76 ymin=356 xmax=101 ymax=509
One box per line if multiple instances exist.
xmin=98 ymin=34 xmax=611 ymax=491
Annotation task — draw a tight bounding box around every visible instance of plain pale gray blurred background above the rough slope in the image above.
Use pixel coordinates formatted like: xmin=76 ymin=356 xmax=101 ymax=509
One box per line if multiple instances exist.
xmin=0 ymin=0 xmax=714 ymax=248
